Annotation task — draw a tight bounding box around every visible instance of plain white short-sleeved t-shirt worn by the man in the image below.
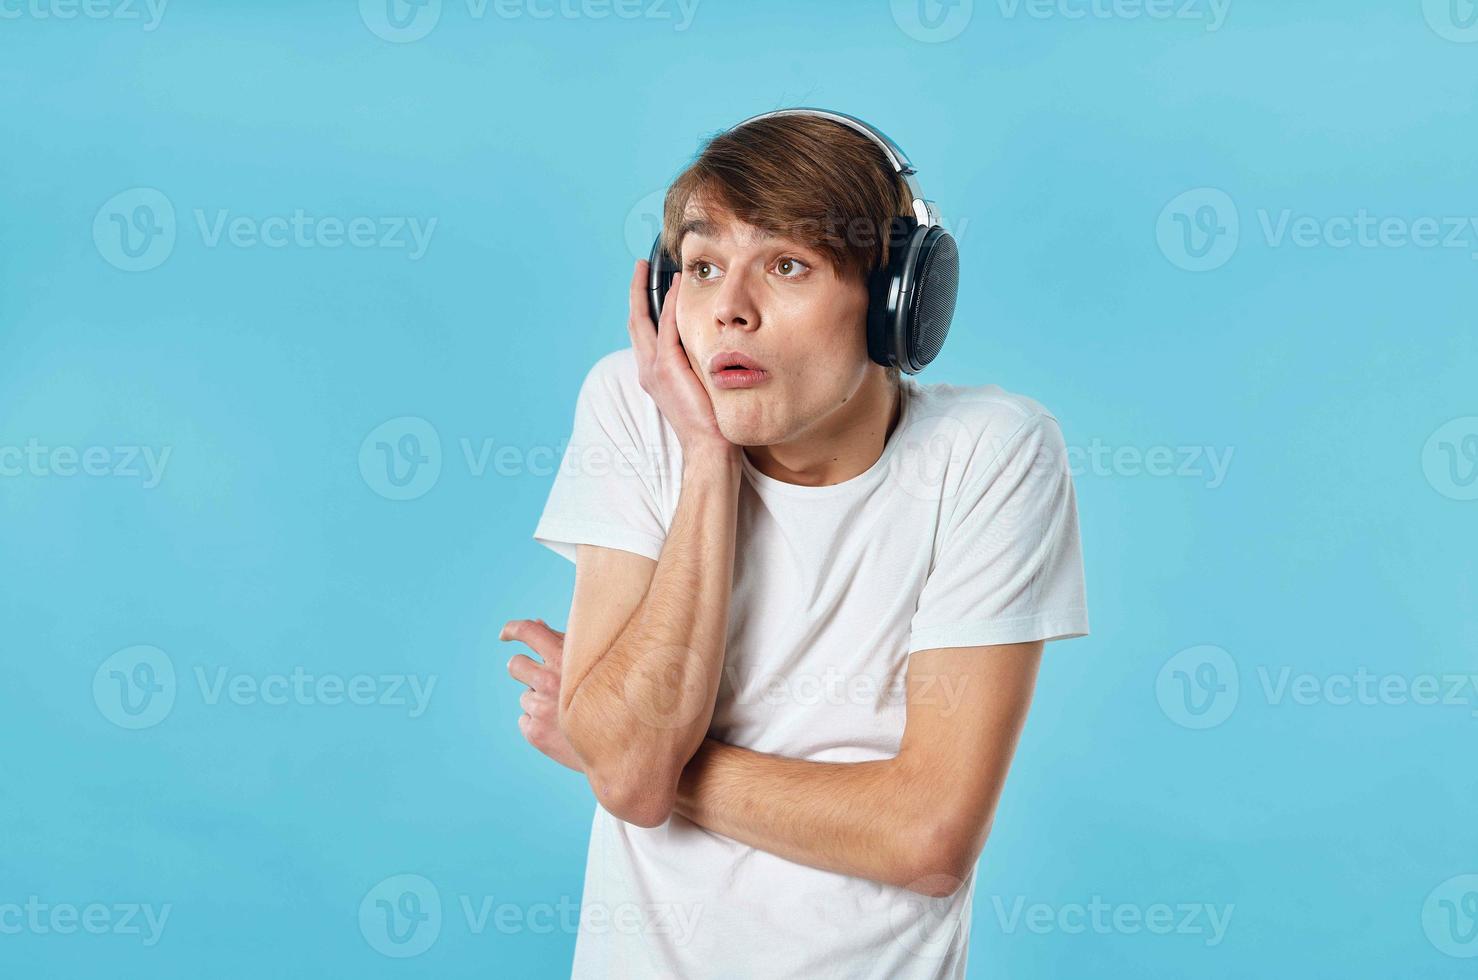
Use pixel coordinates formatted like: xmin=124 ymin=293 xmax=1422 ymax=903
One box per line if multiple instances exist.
xmin=534 ymin=347 xmax=1088 ymax=980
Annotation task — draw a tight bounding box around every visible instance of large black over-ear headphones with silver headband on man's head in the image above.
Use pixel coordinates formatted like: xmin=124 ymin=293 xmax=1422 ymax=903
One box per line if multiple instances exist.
xmin=647 ymin=108 xmax=959 ymax=374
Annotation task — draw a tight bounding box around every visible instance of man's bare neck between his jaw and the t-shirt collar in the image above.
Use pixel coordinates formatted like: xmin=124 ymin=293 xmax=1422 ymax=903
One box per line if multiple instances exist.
xmin=743 ymin=367 xmax=903 ymax=486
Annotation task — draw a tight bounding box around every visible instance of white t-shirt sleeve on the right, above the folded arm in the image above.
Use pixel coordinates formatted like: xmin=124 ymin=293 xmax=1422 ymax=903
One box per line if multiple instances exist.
xmin=909 ymin=414 xmax=1088 ymax=653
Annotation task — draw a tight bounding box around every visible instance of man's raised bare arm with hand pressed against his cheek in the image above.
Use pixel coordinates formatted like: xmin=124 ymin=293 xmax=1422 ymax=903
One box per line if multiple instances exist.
xmin=556 ymin=260 xmax=742 ymax=826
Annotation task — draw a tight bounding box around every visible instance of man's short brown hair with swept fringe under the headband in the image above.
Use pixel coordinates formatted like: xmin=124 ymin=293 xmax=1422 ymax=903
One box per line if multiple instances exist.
xmin=662 ymin=115 xmax=913 ymax=384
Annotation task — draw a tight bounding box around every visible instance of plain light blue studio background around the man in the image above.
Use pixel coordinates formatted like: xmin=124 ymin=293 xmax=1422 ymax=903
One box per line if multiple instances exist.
xmin=0 ymin=0 xmax=1478 ymax=977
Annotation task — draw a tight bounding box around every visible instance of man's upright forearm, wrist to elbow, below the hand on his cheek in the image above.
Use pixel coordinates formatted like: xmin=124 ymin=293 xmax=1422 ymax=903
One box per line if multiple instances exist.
xmin=560 ymin=455 xmax=740 ymax=822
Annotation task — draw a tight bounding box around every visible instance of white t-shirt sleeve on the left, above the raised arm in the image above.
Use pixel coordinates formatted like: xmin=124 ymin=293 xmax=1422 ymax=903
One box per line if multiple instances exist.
xmin=534 ymin=350 xmax=667 ymax=562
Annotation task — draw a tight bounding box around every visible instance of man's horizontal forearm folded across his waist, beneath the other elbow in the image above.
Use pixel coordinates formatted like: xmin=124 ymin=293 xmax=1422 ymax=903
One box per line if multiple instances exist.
xmin=674 ymin=739 xmax=964 ymax=891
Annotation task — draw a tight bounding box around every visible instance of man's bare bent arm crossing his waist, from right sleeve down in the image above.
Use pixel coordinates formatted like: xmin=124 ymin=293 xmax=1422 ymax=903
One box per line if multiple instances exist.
xmin=675 ymin=642 xmax=1042 ymax=896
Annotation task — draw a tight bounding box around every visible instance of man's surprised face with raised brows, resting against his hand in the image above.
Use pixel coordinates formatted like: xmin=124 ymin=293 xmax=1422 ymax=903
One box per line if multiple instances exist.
xmin=677 ymin=207 xmax=882 ymax=446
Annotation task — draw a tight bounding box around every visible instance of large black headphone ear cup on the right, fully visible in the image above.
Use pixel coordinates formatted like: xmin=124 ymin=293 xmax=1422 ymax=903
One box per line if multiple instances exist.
xmin=868 ymin=216 xmax=959 ymax=374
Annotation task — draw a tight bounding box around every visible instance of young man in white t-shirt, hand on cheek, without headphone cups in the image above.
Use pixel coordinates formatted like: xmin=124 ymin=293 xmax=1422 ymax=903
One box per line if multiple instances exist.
xmin=503 ymin=115 xmax=1088 ymax=980
